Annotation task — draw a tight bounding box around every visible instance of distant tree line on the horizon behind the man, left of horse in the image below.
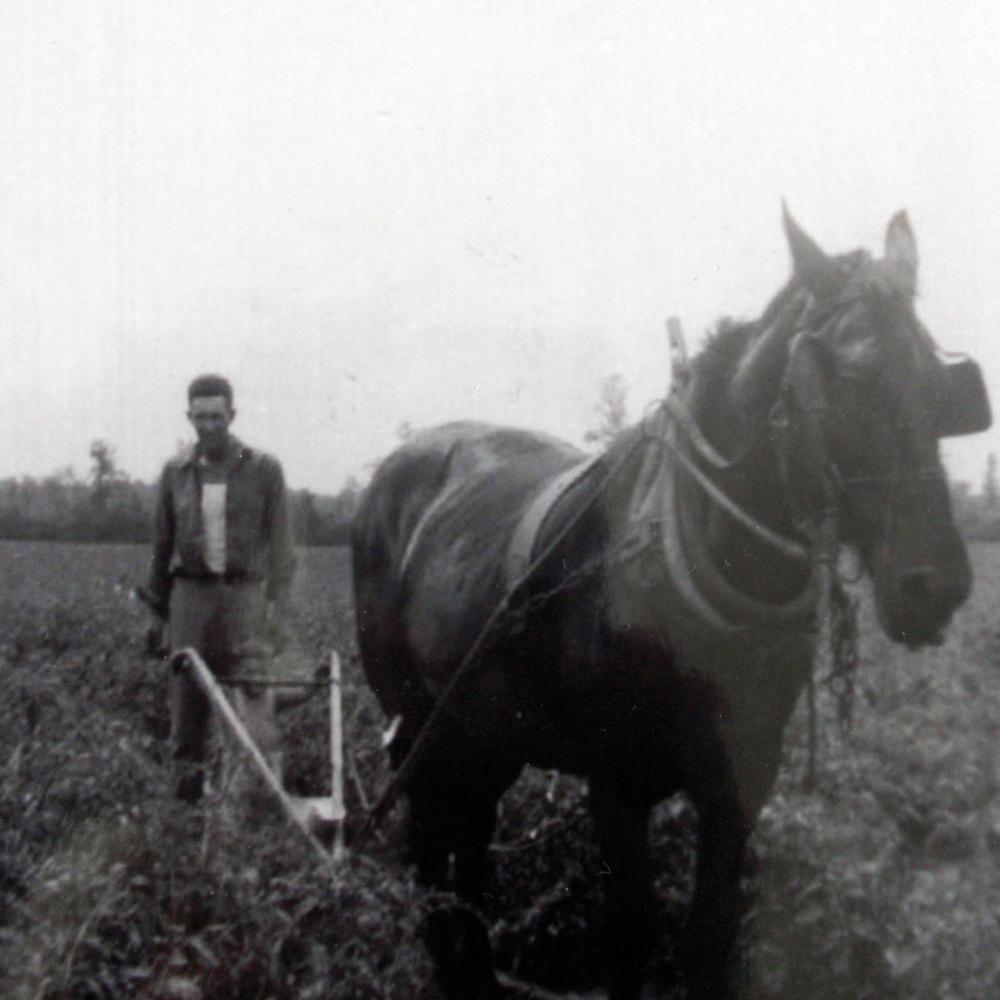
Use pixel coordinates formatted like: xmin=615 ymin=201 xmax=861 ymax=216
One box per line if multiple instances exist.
xmin=0 ymin=440 xmax=360 ymax=545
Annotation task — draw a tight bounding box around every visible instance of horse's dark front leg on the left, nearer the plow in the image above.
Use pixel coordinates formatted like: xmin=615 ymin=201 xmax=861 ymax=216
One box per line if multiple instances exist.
xmin=590 ymin=775 xmax=656 ymax=1000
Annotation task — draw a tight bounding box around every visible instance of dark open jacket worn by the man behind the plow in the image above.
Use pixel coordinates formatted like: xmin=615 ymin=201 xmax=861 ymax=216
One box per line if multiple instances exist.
xmin=148 ymin=438 xmax=295 ymax=615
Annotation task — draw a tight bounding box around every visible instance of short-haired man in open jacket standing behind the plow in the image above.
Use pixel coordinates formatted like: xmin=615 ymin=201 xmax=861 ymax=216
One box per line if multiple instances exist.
xmin=144 ymin=375 xmax=295 ymax=802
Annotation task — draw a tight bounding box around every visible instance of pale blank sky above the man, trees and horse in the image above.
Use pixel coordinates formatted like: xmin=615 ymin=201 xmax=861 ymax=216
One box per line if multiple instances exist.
xmin=0 ymin=0 xmax=1000 ymax=493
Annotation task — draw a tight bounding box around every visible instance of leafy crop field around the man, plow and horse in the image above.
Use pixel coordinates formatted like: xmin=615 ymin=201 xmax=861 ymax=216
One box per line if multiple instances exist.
xmin=0 ymin=543 xmax=1000 ymax=1000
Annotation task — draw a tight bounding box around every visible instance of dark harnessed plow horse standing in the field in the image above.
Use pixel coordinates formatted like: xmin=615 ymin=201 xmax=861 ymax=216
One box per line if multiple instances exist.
xmin=353 ymin=207 xmax=989 ymax=1000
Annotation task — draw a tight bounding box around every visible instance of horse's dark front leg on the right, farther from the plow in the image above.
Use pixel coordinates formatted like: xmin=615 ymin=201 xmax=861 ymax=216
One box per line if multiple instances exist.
xmin=685 ymin=786 xmax=750 ymax=1000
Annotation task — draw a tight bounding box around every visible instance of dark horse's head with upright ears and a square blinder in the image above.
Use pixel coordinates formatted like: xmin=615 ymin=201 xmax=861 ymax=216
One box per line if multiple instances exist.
xmin=732 ymin=212 xmax=990 ymax=647
